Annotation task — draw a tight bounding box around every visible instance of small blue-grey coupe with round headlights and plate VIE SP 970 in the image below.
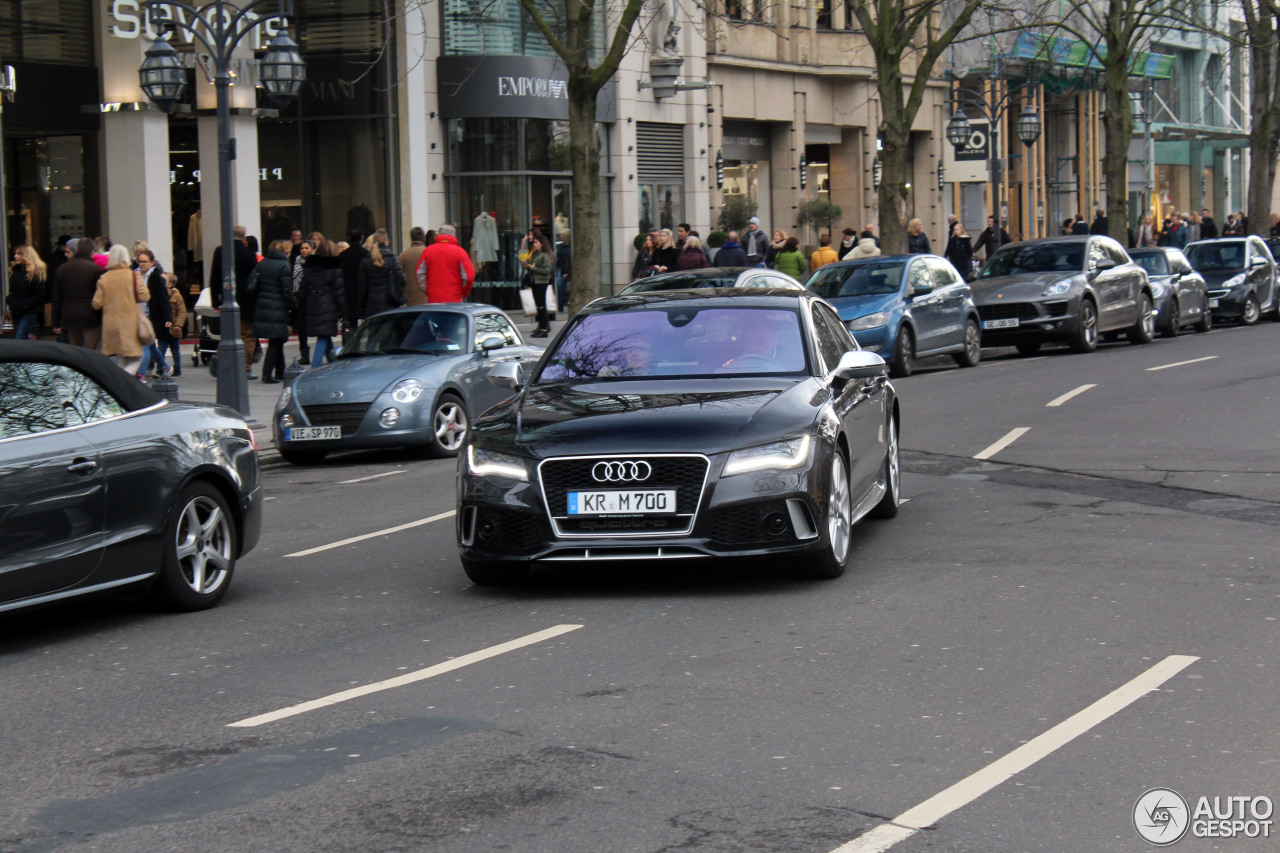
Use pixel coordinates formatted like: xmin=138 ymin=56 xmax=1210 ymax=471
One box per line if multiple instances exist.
xmin=271 ymin=302 xmax=543 ymax=465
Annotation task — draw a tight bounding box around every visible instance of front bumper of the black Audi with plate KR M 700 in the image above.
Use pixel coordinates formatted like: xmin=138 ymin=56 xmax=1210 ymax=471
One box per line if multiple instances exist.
xmin=456 ymin=450 xmax=829 ymax=564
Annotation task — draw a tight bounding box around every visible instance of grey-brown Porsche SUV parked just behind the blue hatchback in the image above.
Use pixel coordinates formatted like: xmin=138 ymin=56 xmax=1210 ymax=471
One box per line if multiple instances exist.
xmin=972 ymin=234 xmax=1155 ymax=355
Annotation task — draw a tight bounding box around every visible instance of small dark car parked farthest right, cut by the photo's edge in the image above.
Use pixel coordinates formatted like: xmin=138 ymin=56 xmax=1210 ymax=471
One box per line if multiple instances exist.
xmin=1183 ymin=237 xmax=1280 ymax=325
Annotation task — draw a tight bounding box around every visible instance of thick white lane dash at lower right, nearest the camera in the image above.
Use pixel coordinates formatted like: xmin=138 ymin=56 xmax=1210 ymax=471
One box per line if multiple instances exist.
xmin=832 ymin=654 xmax=1199 ymax=853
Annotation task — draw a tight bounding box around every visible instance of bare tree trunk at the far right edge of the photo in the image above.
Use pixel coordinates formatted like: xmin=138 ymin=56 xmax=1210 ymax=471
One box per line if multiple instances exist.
xmin=1240 ymin=0 xmax=1280 ymax=237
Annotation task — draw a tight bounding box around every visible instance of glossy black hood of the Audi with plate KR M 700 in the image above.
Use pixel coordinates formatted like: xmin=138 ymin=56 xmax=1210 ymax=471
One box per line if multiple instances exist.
xmin=474 ymin=378 xmax=831 ymax=459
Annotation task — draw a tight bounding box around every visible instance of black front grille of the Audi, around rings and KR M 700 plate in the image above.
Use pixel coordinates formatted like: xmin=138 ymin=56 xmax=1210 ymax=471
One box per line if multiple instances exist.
xmin=538 ymin=453 xmax=710 ymax=537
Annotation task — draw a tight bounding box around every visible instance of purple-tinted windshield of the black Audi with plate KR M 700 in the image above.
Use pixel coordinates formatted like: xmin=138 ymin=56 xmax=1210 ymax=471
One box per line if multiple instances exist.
xmin=536 ymin=307 xmax=808 ymax=383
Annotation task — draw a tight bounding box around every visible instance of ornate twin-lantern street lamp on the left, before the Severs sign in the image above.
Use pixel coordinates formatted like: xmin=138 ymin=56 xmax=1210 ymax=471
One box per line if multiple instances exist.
xmin=138 ymin=0 xmax=307 ymax=418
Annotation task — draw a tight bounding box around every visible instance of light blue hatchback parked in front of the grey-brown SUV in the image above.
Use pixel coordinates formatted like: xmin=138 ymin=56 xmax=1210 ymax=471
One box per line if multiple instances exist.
xmin=805 ymin=255 xmax=982 ymax=377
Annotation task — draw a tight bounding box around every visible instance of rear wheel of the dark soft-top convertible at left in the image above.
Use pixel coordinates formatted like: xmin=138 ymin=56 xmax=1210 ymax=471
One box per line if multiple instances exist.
xmin=150 ymin=482 xmax=237 ymax=611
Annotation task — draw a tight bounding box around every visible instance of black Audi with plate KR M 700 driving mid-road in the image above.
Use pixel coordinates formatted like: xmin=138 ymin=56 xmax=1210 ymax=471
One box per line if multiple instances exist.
xmin=457 ymin=288 xmax=899 ymax=584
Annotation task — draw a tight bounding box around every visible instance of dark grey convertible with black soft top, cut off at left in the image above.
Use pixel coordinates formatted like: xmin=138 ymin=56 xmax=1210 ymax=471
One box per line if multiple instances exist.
xmin=0 ymin=342 xmax=262 ymax=611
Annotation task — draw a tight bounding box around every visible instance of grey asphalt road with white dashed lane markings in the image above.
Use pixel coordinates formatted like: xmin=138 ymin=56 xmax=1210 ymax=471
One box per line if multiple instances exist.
xmin=0 ymin=323 xmax=1280 ymax=853
